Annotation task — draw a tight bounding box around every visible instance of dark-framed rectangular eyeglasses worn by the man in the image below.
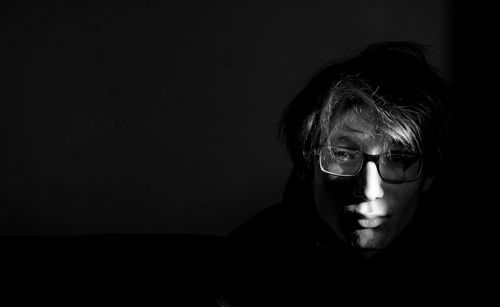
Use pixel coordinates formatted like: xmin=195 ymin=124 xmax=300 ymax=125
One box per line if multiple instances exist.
xmin=319 ymin=146 xmax=423 ymax=183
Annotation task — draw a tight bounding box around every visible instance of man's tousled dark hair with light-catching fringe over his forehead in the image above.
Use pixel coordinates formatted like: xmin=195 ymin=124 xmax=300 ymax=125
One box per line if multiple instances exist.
xmin=280 ymin=42 xmax=449 ymax=180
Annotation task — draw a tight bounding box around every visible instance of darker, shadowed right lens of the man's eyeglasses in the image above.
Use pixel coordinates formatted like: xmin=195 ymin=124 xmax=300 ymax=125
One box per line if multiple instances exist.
xmin=379 ymin=152 xmax=422 ymax=181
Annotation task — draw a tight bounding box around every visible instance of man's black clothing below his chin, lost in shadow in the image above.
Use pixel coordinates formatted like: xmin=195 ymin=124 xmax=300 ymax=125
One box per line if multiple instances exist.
xmin=223 ymin=174 xmax=466 ymax=307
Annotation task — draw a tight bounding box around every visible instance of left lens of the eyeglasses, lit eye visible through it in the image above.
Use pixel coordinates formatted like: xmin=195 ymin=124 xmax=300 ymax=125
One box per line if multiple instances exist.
xmin=319 ymin=147 xmax=363 ymax=176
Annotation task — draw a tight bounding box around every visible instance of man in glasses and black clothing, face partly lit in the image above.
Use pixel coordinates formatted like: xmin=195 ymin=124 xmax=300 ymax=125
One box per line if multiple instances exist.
xmin=222 ymin=42 xmax=458 ymax=306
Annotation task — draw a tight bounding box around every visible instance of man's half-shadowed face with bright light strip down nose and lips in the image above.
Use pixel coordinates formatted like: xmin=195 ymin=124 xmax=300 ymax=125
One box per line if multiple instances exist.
xmin=313 ymin=115 xmax=432 ymax=251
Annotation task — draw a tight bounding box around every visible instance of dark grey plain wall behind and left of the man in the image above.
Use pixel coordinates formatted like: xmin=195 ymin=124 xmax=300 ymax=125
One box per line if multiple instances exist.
xmin=0 ymin=0 xmax=454 ymax=235
